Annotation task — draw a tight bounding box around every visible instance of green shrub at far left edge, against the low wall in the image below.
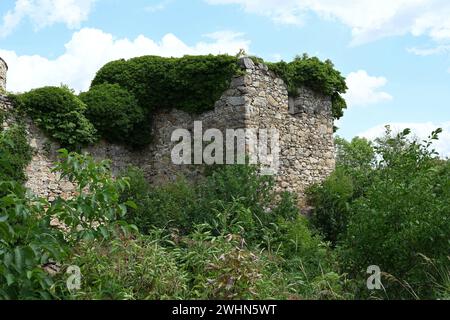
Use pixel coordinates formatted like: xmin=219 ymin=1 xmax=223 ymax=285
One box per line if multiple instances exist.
xmin=0 ymin=124 xmax=32 ymax=182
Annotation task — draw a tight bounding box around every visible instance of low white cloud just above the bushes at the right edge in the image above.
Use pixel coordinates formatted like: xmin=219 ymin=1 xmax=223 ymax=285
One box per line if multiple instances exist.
xmin=359 ymin=121 xmax=450 ymax=157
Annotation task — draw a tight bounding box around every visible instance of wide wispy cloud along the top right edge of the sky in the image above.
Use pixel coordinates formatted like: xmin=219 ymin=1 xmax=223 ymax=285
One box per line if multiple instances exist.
xmin=205 ymin=0 xmax=450 ymax=44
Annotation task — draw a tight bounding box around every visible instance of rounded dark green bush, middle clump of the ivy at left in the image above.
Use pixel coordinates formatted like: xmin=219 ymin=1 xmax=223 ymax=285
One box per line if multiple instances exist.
xmin=80 ymin=84 xmax=145 ymax=144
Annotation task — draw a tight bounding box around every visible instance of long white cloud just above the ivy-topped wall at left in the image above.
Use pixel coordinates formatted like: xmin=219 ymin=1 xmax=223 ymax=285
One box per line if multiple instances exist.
xmin=0 ymin=28 xmax=250 ymax=92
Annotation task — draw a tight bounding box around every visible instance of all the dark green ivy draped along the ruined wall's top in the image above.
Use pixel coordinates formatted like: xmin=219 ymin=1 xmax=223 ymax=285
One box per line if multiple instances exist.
xmin=15 ymin=55 xmax=347 ymax=149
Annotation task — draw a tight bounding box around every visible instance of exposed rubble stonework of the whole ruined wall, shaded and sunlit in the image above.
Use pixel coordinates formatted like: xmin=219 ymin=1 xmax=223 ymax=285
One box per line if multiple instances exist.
xmin=0 ymin=58 xmax=335 ymax=205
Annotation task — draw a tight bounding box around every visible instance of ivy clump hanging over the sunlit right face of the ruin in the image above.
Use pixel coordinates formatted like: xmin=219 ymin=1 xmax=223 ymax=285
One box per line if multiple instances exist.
xmin=267 ymin=54 xmax=348 ymax=119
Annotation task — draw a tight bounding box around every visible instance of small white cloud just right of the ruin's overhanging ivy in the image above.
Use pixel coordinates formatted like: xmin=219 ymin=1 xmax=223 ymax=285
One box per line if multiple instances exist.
xmin=344 ymin=70 xmax=393 ymax=107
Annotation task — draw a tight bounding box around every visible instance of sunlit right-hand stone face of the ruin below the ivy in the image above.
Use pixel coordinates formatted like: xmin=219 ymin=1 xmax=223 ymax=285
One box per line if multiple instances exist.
xmin=237 ymin=61 xmax=335 ymax=200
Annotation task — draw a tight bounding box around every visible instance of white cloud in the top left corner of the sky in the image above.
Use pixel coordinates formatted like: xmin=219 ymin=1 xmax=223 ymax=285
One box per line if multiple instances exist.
xmin=0 ymin=0 xmax=96 ymax=37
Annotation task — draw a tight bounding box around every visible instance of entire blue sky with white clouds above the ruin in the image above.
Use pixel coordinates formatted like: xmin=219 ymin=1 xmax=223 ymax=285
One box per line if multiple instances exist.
xmin=0 ymin=0 xmax=450 ymax=156
